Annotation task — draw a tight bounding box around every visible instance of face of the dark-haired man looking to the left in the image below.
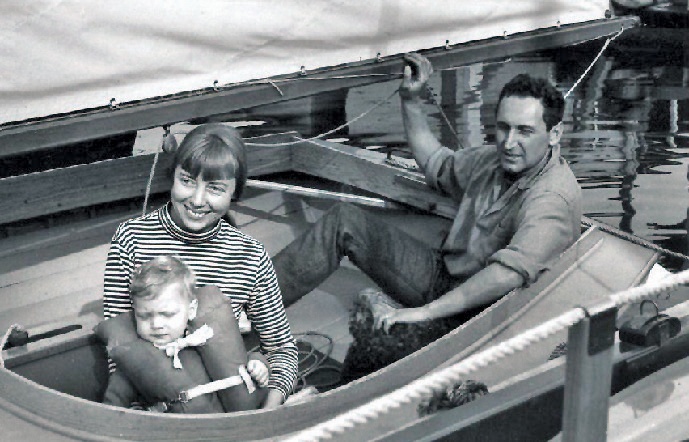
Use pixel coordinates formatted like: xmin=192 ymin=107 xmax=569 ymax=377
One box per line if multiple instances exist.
xmin=496 ymin=96 xmax=560 ymax=174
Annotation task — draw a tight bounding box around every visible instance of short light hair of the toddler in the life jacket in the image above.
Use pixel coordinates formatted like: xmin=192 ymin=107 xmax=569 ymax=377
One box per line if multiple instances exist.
xmin=129 ymin=255 xmax=196 ymax=300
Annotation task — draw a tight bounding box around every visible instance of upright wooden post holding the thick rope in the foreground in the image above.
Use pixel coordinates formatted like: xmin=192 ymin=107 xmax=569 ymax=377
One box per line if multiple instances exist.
xmin=562 ymin=308 xmax=617 ymax=442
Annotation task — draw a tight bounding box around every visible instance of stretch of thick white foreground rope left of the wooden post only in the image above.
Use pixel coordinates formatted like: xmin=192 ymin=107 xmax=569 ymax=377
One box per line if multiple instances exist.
xmin=287 ymin=308 xmax=585 ymax=442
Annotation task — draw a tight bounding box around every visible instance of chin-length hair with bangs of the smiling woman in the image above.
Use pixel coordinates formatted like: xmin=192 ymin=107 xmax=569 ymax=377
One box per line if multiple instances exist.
xmin=173 ymin=123 xmax=247 ymax=201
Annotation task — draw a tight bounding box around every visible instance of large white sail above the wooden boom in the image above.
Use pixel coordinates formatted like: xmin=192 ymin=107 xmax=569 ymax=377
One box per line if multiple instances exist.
xmin=0 ymin=0 xmax=609 ymax=124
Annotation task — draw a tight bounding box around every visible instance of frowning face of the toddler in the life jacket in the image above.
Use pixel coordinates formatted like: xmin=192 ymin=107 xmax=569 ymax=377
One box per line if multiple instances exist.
xmin=134 ymin=283 xmax=194 ymax=346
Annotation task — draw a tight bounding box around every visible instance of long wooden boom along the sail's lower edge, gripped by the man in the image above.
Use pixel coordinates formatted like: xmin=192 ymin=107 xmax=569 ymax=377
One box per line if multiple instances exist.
xmin=0 ymin=17 xmax=639 ymax=156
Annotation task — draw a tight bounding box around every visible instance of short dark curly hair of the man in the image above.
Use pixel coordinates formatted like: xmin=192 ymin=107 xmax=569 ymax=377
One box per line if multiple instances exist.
xmin=496 ymin=74 xmax=565 ymax=130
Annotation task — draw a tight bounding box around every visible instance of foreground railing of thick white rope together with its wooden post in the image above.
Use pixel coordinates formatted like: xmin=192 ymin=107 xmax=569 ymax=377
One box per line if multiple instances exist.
xmin=287 ymin=270 xmax=689 ymax=442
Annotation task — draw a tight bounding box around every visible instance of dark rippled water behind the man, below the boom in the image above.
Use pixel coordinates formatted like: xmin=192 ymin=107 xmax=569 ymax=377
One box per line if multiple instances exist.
xmin=238 ymin=29 xmax=689 ymax=269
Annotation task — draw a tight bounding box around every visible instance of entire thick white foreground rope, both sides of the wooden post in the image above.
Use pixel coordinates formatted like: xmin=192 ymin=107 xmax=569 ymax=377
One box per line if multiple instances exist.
xmin=287 ymin=270 xmax=689 ymax=442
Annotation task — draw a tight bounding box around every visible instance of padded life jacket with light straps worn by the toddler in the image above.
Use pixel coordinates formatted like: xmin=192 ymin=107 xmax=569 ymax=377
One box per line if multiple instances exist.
xmin=94 ymin=286 xmax=269 ymax=414
